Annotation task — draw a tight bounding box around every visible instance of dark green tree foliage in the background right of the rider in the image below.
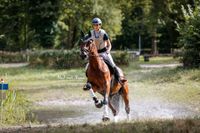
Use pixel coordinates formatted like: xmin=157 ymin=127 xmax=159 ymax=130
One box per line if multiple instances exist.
xmin=114 ymin=0 xmax=189 ymax=53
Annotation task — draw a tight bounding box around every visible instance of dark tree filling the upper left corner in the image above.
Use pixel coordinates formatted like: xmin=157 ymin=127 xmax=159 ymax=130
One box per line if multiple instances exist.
xmin=0 ymin=0 xmax=25 ymax=51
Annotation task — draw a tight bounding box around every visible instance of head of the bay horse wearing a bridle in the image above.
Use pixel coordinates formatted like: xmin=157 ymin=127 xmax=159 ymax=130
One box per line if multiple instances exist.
xmin=80 ymin=32 xmax=97 ymax=59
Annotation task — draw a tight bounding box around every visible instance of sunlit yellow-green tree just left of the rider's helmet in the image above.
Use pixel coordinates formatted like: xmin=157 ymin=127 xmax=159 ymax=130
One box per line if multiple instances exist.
xmin=55 ymin=0 xmax=93 ymax=49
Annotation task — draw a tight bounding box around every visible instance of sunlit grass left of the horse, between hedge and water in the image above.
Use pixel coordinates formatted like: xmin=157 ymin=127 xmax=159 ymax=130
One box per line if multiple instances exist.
xmin=0 ymin=67 xmax=86 ymax=100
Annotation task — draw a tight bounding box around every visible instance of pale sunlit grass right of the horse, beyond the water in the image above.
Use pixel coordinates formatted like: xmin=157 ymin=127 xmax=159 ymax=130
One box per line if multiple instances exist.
xmin=127 ymin=68 xmax=200 ymax=107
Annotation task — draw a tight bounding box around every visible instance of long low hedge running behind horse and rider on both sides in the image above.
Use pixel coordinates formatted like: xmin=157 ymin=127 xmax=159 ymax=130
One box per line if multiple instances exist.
xmin=0 ymin=49 xmax=133 ymax=69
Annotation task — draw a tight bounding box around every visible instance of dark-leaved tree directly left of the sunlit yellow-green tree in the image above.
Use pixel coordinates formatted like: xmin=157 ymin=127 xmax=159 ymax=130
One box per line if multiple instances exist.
xmin=28 ymin=0 xmax=60 ymax=48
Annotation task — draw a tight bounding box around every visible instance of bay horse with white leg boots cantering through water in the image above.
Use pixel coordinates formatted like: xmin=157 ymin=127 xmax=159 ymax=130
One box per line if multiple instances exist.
xmin=80 ymin=39 xmax=130 ymax=122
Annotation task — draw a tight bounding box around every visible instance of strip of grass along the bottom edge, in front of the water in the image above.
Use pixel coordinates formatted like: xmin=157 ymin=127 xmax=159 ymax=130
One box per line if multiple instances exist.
xmin=1 ymin=119 xmax=200 ymax=133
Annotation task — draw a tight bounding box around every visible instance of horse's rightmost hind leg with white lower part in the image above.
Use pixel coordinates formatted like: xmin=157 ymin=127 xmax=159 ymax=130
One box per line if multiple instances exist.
xmin=122 ymin=83 xmax=131 ymax=120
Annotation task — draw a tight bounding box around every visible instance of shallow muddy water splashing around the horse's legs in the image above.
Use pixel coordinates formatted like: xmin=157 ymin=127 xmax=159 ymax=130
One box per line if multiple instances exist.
xmin=34 ymin=99 xmax=200 ymax=124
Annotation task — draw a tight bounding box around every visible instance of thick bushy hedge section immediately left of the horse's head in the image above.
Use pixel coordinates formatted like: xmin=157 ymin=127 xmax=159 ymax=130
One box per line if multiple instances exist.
xmin=30 ymin=49 xmax=84 ymax=69
